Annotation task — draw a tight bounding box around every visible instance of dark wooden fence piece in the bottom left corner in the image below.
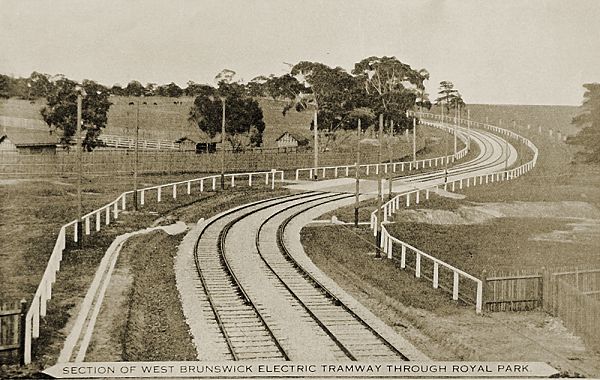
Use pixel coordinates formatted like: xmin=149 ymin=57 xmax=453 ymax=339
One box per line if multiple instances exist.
xmin=0 ymin=300 xmax=27 ymax=364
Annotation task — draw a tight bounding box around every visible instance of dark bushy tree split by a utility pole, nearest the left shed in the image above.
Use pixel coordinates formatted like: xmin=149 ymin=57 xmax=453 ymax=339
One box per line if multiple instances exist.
xmin=41 ymin=77 xmax=111 ymax=151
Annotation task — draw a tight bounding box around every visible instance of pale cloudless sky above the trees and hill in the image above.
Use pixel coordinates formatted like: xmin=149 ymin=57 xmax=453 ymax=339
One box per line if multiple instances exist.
xmin=0 ymin=0 xmax=600 ymax=105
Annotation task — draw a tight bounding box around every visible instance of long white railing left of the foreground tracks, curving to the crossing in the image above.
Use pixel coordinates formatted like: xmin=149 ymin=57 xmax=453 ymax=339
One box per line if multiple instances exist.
xmin=24 ymin=169 xmax=284 ymax=364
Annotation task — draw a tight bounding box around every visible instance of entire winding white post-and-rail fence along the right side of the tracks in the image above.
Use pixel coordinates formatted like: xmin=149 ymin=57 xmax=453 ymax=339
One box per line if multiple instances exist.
xmin=369 ymin=113 xmax=538 ymax=313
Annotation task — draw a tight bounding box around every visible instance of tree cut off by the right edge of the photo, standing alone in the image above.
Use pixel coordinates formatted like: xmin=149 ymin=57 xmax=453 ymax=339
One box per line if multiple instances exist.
xmin=568 ymin=83 xmax=600 ymax=163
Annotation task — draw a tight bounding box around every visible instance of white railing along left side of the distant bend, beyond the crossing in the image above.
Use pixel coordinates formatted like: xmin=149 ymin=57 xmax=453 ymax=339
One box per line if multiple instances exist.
xmin=296 ymin=121 xmax=468 ymax=181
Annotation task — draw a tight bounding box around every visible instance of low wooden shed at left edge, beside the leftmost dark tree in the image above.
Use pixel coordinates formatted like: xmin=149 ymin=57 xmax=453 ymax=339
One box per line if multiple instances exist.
xmin=0 ymin=126 xmax=59 ymax=154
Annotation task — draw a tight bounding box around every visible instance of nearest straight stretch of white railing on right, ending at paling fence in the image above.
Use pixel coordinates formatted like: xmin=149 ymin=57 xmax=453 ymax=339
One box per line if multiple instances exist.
xmin=380 ymin=225 xmax=483 ymax=314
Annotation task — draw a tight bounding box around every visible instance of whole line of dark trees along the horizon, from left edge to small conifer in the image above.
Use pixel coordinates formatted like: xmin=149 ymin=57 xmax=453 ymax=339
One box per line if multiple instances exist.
xmin=0 ymin=56 xmax=464 ymax=150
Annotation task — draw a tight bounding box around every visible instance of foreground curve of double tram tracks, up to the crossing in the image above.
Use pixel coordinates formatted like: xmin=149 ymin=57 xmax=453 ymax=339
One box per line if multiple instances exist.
xmin=195 ymin=192 xmax=407 ymax=361
